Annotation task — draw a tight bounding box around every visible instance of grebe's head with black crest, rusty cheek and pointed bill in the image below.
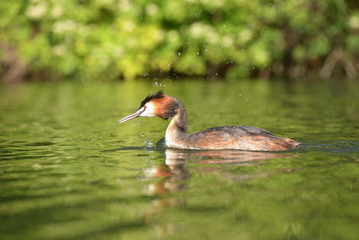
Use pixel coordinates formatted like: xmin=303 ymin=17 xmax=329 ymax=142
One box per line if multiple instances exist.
xmin=118 ymin=91 xmax=178 ymax=123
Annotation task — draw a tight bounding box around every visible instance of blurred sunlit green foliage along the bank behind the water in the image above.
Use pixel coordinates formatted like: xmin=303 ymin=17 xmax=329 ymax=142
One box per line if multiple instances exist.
xmin=0 ymin=0 xmax=359 ymax=81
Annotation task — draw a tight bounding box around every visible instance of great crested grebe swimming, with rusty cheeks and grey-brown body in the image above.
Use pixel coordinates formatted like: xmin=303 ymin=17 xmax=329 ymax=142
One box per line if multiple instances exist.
xmin=119 ymin=91 xmax=300 ymax=151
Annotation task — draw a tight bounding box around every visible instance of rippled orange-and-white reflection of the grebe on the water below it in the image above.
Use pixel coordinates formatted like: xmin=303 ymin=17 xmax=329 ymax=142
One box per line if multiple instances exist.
xmin=108 ymin=138 xmax=299 ymax=195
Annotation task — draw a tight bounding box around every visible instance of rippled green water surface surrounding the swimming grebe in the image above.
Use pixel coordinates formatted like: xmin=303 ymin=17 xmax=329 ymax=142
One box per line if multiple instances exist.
xmin=0 ymin=80 xmax=359 ymax=239
